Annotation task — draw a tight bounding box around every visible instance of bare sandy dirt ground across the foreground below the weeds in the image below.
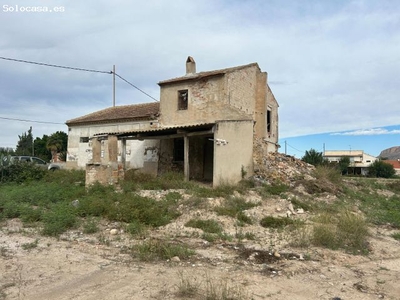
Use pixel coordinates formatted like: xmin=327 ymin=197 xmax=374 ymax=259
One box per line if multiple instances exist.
xmin=0 ymin=190 xmax=400 ymax=300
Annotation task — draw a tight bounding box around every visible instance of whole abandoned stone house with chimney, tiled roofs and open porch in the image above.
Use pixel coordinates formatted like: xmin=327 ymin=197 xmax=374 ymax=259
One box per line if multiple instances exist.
xmin=66 ymin=57 xmax=279 ymax=186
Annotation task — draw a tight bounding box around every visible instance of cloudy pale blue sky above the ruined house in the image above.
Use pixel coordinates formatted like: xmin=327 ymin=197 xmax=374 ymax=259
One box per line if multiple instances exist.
xmin=0 ymin=0 xmax=400 ymax=157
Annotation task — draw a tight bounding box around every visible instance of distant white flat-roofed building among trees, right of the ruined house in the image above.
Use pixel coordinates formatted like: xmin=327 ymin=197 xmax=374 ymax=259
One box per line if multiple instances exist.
xmin=323 ymin=150 xmax=377 ymax=175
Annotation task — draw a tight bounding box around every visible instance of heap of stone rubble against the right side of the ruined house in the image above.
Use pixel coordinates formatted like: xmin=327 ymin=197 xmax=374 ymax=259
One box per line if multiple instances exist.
xmin=254 ymin=141 xmax=315 ymax=185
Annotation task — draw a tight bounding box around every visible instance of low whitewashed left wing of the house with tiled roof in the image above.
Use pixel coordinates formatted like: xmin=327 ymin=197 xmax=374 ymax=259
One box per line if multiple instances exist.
xmin=66 ymin=103 xmax=159 ymax=169
